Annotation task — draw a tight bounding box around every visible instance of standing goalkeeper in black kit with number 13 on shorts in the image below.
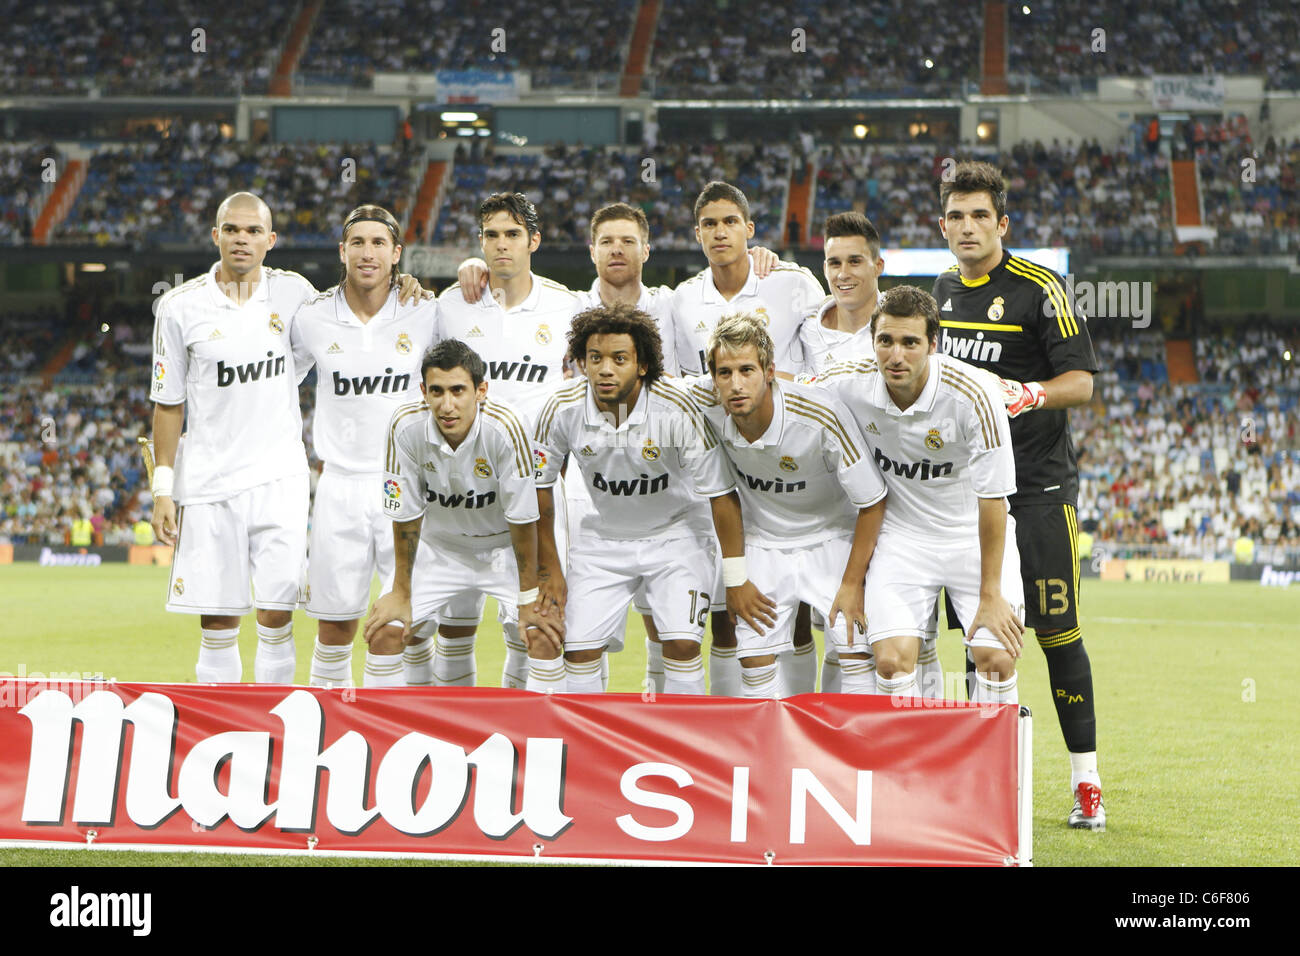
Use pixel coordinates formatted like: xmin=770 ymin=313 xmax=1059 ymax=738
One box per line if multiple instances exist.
xmin=933 ymin=163 xmax=1106 ymax=830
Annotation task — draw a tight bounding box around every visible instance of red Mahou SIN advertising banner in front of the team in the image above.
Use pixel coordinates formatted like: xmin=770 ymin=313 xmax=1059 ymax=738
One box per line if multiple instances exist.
xmin=0 ymin=679 xmax=1021 ymax=866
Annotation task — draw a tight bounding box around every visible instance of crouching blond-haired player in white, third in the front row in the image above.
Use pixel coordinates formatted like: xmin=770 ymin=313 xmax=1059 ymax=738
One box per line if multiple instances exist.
xmin=690 ymin=312 xmax=885 ymax=697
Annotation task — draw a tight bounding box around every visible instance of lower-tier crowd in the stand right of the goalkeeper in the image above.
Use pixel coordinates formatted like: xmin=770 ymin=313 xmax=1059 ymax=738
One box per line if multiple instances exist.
xmin=1071 ymin=325 xmax=1300 ymax=564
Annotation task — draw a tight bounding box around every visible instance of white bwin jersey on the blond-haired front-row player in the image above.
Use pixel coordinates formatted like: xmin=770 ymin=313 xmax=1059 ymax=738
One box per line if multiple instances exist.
xmin=688 ymin=375 xmax=888 ymax=548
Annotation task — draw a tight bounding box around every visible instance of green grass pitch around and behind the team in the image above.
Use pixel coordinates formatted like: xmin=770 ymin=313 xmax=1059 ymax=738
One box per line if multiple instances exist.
xmin=0 ymin=564 xmax=1300 ymax=866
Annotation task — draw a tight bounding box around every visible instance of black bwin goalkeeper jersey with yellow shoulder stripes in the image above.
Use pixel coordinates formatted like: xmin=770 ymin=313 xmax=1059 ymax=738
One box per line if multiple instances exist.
xmin=935 ymin=251 xmax=1097 ymax=505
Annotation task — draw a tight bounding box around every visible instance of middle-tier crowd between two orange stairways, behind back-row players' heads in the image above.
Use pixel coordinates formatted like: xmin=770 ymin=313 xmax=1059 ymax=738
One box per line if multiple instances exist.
xmin=433 ymin=143 xmax=792 ymax=248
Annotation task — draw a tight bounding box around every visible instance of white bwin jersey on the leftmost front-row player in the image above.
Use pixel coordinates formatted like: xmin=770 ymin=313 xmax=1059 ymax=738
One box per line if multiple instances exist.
xmin=384 ymin=399 xmax=538 ymax=551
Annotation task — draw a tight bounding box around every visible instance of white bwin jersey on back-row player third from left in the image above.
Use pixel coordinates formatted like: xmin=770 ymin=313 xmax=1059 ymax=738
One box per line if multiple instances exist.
xmin=438 ymin=273 xmax=577 ymax=421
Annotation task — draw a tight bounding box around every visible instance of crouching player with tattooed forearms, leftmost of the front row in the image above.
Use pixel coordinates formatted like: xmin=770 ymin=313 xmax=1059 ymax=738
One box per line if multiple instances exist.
xmin=365 ymin=339 xmax=564 ymax=671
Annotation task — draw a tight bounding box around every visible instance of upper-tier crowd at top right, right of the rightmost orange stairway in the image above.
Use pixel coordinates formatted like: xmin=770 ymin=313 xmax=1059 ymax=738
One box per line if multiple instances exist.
xmin=1008 ymin=0 xmax=1300 ymax=90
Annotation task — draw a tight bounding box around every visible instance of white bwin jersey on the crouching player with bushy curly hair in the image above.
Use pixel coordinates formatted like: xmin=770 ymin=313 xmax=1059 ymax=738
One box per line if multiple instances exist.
xmin=533 ymin=378 xmax=736 ymax=541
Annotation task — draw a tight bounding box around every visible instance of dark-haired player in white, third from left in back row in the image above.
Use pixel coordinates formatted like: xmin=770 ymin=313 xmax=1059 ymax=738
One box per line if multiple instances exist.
xmin=434 ymin=193 xmax=577 ymax=688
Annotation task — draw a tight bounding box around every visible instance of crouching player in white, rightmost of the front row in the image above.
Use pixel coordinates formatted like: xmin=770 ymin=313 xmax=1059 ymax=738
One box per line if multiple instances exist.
xmin=818 ymin=286 xmax=1024 ymax=704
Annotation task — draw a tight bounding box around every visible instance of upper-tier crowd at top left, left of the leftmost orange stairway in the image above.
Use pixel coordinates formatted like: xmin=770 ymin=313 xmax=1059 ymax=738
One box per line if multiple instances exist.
xmin=0 ymin=0 xmax=295 ymax=96
